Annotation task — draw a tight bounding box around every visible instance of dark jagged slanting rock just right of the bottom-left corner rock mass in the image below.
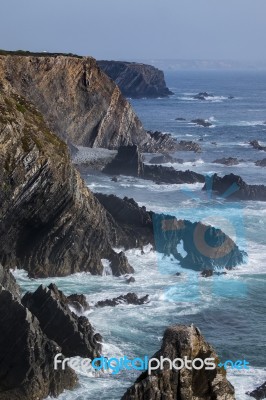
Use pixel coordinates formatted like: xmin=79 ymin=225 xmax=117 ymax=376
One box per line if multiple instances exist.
xmin=22 ymin=284 xmax=101 ymax=358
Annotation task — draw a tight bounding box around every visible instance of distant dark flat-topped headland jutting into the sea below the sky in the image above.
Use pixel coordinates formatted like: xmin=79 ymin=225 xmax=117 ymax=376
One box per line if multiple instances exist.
xmin=97 ymin=61 xmax=173 ymax=98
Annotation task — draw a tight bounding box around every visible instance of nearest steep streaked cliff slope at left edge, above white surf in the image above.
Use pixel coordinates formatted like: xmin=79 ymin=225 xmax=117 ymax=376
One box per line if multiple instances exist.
xmin=0 ymin=83 xmax=133 ymax=277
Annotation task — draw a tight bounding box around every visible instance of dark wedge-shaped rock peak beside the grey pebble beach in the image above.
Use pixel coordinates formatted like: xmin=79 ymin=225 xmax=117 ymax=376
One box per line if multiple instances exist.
xmin=102 ymin=145 xmax=143 ymax=176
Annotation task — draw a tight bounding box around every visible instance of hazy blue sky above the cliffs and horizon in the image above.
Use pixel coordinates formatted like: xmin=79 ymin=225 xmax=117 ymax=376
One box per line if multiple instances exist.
xmin=0 ymin=0 xmax=266 ymax=60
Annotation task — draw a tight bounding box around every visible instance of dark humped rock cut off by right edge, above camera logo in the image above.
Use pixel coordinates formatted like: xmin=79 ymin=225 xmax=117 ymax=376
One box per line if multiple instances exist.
xmin=203 ymin=174 xmax=266 ymax=201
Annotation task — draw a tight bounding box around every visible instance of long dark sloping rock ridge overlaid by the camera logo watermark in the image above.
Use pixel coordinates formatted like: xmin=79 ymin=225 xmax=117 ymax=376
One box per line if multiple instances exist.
xmin=96 ymin=194 xmax=245 ymax=271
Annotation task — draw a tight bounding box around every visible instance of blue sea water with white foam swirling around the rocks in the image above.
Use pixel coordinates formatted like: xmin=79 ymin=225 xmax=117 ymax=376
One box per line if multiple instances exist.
xmin=15 ymin=71 xmax=266 ymax=400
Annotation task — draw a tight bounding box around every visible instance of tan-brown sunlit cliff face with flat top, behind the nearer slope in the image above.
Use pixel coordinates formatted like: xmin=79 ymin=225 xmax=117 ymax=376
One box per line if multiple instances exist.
xmin=0 ymin=55 xmax=149 ymax=149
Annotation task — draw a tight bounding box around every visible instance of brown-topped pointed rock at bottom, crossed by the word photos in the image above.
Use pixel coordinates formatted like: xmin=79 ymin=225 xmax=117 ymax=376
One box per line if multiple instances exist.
xmin=121 ymin=325 xmax=235 ymax=400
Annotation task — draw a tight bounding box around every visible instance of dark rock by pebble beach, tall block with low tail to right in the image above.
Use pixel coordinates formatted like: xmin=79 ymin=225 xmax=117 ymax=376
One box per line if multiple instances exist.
xmin=103 ymin=146 xmax=205 ymax=184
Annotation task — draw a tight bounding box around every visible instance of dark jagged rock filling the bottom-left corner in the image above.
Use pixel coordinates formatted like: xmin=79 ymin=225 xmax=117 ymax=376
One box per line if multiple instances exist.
xmin=0 ymin=285 xmax=77 ymax=400
